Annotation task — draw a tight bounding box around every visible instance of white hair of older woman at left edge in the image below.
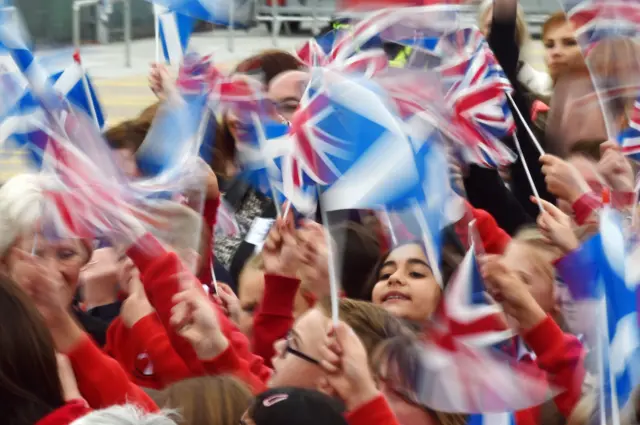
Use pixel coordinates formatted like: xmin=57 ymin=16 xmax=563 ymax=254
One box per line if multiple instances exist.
xmin=0 ymin=173 xmax=44 ymax=257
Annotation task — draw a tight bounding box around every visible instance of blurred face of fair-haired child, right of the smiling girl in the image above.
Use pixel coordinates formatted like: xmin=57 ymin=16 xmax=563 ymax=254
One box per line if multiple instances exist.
xmin=504 ymin=241 xmax=556 ymax=313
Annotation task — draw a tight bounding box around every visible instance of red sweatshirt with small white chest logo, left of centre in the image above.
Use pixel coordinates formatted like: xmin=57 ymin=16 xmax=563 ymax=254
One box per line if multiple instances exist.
xmin=104 ymin=312 xmax=193 ymax=390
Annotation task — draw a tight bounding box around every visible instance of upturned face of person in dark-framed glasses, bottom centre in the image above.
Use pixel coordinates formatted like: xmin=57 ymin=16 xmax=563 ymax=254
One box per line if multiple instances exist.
xmin=269 ymin=308 xmax=329 ymax=389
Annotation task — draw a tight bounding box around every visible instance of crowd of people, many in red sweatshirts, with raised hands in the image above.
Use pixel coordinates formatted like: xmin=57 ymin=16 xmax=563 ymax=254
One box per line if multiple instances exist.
xmin=0 ymin=0 xmax=640 ymax=425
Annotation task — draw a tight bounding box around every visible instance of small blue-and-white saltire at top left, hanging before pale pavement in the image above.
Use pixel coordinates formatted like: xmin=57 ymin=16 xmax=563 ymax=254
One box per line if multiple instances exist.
xmin=153 ymin=4 xmax=194 ymax=65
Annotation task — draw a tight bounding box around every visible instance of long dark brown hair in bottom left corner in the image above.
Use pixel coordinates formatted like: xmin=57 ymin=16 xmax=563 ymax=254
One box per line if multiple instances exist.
xmin=0 ymin=276 xmax=64 ymax=425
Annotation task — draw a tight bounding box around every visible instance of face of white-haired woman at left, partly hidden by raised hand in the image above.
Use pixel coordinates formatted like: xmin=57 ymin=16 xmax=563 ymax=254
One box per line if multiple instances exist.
xmin=6 ymin=235 xmax=89 ymax=305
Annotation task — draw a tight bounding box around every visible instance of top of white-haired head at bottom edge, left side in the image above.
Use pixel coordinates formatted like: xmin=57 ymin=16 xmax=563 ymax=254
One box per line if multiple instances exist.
xmin=71 ymin=404 xmax=177 ymax=425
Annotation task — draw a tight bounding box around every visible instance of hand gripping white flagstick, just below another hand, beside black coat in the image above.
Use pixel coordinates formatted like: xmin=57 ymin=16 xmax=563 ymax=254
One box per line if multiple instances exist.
xmin=531 ymin=197 xmax=580 ymax=254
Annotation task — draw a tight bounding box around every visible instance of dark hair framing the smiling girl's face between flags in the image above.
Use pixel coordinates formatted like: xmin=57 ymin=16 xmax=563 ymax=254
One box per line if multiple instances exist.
xmin=363 ymin=226 xmax=465 ymax=301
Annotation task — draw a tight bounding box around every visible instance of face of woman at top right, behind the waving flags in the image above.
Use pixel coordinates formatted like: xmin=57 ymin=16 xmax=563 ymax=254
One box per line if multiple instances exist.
xmin=542 ymin=22 xmax=586 ymax=81
